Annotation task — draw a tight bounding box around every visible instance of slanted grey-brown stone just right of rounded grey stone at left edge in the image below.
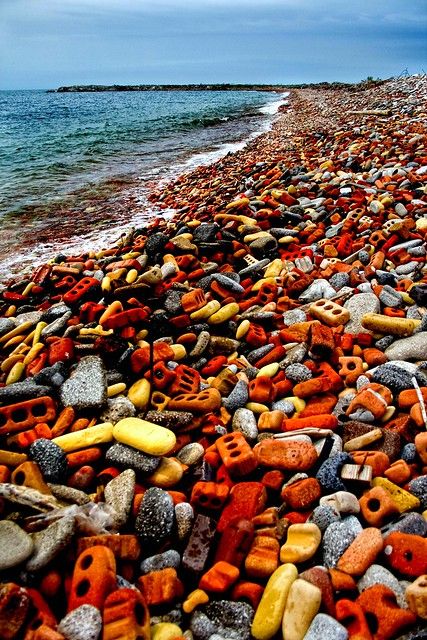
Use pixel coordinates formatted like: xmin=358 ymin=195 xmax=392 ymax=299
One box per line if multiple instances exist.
xmin=26 ymin=516 xmax=76 ymax=571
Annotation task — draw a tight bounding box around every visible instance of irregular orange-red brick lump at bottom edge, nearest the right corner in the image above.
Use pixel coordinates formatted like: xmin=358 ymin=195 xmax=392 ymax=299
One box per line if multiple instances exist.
xmin=356 ymin=584 xmax=417 ymax=640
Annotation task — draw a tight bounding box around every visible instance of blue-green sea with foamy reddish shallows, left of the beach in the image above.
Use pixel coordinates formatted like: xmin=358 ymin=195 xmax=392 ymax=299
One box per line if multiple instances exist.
xmin=0 ymin=90 xmax=288 ymax=282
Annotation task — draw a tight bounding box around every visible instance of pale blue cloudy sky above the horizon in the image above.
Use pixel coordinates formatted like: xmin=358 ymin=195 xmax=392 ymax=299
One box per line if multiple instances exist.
xmin=0 ymin=0 xmax=427 ymax=89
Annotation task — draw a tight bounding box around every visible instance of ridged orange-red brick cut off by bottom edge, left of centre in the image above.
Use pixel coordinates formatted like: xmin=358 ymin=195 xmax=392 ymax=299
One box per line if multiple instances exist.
xmin=102 ymin=589 xmax=151 ymax=640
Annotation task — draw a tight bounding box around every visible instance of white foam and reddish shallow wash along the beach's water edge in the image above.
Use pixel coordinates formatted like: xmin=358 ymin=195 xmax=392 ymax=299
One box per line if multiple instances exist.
xmin=0 ymin=92 xmax=288 ymax=285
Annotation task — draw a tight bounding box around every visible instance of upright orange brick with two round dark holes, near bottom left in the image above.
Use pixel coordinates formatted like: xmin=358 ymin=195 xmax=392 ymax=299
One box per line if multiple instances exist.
xmin=68 ymin=545 xmax=116 ymax=611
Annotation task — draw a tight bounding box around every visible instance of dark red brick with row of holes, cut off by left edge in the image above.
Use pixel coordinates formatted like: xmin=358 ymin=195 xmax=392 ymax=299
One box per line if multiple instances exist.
xmin=0 ymin=396 xmax=56 ymax=436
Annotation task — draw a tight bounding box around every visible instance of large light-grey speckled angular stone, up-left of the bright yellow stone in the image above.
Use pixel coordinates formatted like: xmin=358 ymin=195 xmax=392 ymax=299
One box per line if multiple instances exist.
xmin=60 ymin=356 xmax=107 ymax=411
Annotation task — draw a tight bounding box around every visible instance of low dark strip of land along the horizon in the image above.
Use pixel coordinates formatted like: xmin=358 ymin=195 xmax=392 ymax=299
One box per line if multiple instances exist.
xmin=47 ymin=82 xmax=368 ymax=93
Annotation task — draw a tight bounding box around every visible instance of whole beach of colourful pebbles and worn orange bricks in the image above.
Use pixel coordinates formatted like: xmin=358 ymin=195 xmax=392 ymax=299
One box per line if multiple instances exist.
xmin=0 ymin=78 xmax=427 ymax=640
